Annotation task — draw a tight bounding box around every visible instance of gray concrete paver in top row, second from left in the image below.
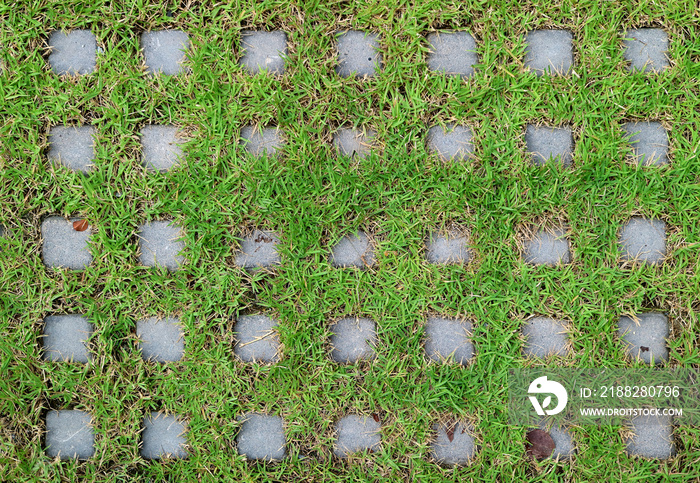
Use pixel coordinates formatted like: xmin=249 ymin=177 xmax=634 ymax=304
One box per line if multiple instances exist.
xmin=141 ymin=30 xmax=190 ymax=75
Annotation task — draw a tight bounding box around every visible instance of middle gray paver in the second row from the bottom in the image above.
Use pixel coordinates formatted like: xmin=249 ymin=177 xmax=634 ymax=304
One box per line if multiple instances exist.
xmin=331 ymin=317 xmax=377 ymax=364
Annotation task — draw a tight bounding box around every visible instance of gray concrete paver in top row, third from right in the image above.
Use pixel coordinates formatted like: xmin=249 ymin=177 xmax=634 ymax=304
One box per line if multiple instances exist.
xmin=428 ymin=31 xmax=479 ymax=78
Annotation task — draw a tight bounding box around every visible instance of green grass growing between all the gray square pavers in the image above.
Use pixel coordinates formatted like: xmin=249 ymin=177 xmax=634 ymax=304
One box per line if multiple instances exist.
xmin=0 ymin=0 xmax=700 ymax=481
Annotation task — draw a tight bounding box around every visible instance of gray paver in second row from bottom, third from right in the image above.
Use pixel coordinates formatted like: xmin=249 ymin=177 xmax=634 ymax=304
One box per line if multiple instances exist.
xmin=425 ymin=317 xmax=474 ymax=365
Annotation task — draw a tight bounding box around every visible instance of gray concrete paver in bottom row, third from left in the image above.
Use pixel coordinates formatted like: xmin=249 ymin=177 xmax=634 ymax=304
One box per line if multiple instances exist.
xmin=236 ymin=413 xmax=287 ymax=461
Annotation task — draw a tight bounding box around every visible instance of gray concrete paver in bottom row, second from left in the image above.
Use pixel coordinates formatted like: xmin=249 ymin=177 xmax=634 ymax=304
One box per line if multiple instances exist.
xmin=141 ymin=412 xmax=187 ymax=460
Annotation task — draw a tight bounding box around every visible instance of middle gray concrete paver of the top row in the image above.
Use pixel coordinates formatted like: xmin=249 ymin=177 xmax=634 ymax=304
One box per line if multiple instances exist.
xmin=335 ymin=30 xmax=382 ymax=77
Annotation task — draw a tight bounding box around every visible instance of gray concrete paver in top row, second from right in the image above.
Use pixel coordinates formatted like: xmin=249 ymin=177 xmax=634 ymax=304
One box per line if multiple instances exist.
xmin=525 ymin=30 xmax=574 ymax=76
